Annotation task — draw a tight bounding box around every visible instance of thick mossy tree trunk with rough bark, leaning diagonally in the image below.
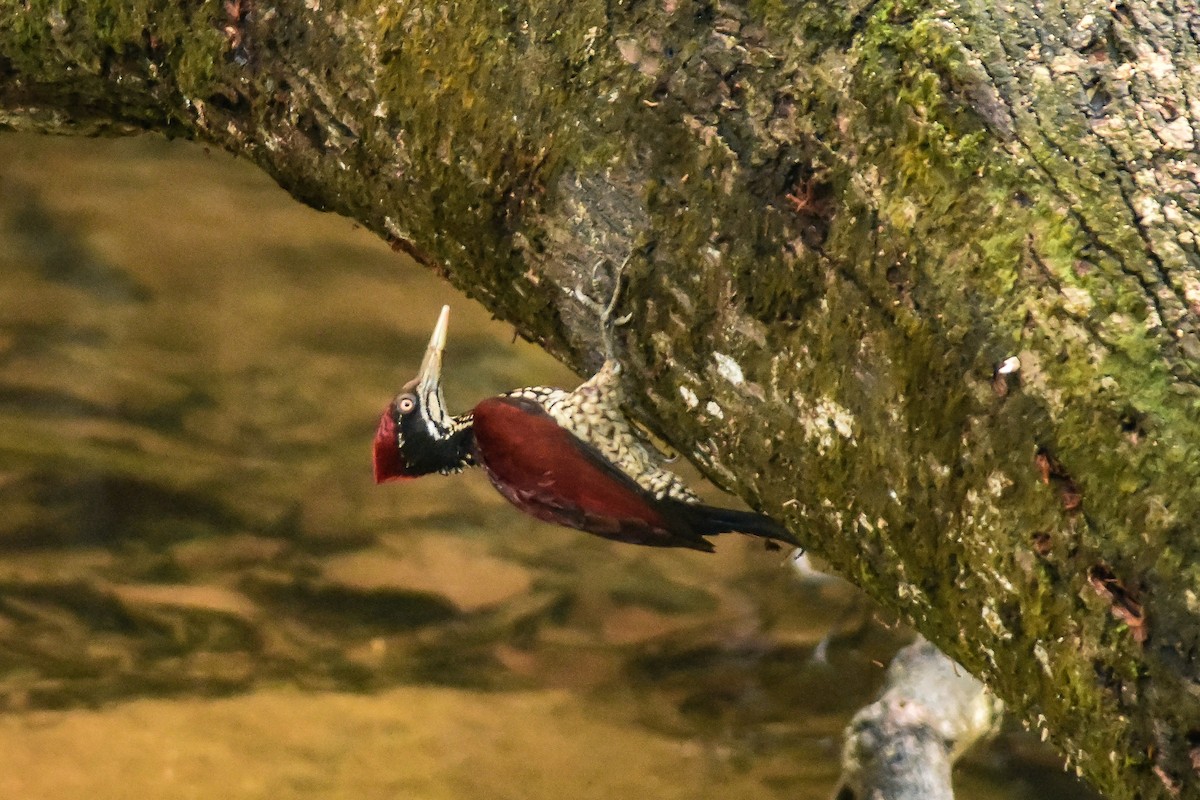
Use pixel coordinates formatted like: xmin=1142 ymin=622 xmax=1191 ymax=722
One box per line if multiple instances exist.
xmin=0 ymin=0 xmax=1200 ymax=798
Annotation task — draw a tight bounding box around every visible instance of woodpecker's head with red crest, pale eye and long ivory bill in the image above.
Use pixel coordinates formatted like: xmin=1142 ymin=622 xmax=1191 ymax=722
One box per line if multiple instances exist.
xmin=374 ymin=306 xmax=470 ymax=483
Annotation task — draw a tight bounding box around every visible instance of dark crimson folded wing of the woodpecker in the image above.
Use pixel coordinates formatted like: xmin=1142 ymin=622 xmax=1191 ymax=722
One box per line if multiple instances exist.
xmin=473 ymin=397 xmax=713 ymax=552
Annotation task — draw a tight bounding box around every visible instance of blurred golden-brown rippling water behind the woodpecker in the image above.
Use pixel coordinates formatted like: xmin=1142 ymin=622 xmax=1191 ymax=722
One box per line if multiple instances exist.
xmin=0 ymin=136 xmax=1090 ymax=800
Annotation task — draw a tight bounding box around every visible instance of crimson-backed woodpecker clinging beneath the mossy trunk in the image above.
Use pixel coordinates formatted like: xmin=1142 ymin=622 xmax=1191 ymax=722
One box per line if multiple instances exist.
xmin=374 ymin=306 xmax=800 ymax=552
